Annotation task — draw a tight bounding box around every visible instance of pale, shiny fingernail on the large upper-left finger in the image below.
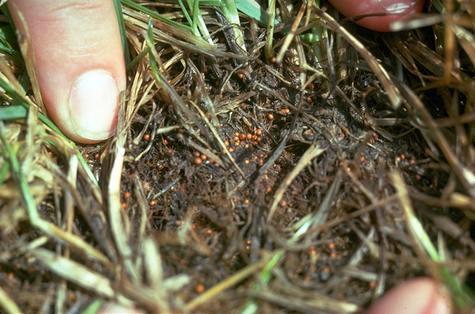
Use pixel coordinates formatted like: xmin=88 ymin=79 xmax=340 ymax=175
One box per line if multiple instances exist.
xmin=69 ymin=70 xmax=119 ymax=141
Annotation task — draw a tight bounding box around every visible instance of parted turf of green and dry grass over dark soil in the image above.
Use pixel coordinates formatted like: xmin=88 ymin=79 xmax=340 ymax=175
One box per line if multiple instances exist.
xmin=0 ymin=0 xmax=475 ymax=314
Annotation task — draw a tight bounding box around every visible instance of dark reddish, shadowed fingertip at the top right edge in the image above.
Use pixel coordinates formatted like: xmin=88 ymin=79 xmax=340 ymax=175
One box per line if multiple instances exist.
xmin=329 ymin=0 xmax=424 ymax=32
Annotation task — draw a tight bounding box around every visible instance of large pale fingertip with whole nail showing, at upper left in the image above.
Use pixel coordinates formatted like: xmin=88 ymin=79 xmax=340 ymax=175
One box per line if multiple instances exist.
xmin=8 ymin=0 xmax=126 ymax=143
